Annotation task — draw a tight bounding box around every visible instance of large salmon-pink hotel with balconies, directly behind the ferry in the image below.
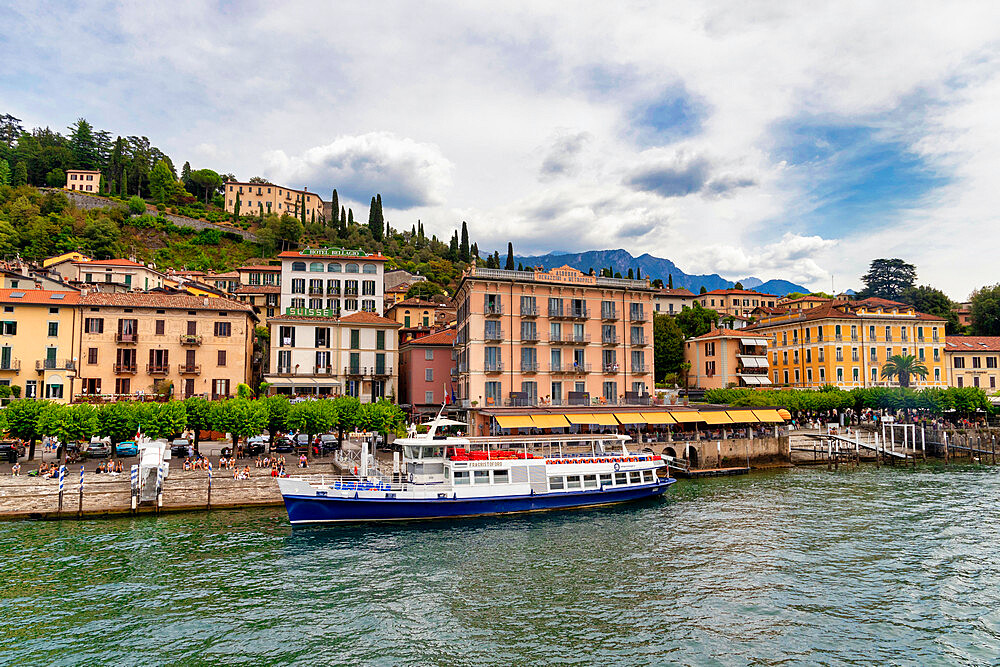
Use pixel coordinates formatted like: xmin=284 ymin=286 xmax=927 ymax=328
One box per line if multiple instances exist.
xmin=455 ymin=266 xmax=656 ymax=409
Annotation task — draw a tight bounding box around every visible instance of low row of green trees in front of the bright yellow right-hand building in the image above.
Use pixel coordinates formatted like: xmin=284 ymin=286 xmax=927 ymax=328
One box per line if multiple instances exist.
xmin=705 ymin=385 xmax=995 ymax=415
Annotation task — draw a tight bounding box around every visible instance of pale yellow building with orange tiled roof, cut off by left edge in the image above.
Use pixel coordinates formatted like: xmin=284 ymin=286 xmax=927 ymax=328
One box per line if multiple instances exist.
xmin=0 ymin=289 xmax=80 ymax=403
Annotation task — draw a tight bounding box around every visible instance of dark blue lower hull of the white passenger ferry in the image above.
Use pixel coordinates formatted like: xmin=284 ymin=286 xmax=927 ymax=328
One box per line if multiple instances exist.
xmin=284 ymin=479 xmax=676 ymax=524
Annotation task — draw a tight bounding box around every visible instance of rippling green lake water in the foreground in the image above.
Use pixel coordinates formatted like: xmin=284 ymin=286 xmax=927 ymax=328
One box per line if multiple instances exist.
xmin=0 ymin=466 xmax=1000 ymax=665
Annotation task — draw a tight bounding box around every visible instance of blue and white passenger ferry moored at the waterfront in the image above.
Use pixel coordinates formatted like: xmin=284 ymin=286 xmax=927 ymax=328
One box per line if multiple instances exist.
xmin=278 ymin=418 xmax=676 ymax=524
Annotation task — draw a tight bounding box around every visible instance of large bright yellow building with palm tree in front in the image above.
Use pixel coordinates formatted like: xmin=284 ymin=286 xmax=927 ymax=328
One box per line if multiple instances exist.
xmin=744 ymin=298 xmax=948 ymax=389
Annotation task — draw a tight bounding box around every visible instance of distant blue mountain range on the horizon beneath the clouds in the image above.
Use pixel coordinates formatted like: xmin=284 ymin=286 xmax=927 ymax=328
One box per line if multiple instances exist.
xmin=514 ymin=249 xmax=810 ymax=296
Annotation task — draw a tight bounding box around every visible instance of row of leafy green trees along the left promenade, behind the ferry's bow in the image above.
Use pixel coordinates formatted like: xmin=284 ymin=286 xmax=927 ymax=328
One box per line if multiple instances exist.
xmin=0 ymin=396 xmax=406 ymax=460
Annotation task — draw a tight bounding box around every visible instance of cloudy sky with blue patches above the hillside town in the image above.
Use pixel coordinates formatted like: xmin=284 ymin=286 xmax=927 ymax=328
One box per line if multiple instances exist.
xmin=0 ymin=0 xmax=1000 ymax=299
